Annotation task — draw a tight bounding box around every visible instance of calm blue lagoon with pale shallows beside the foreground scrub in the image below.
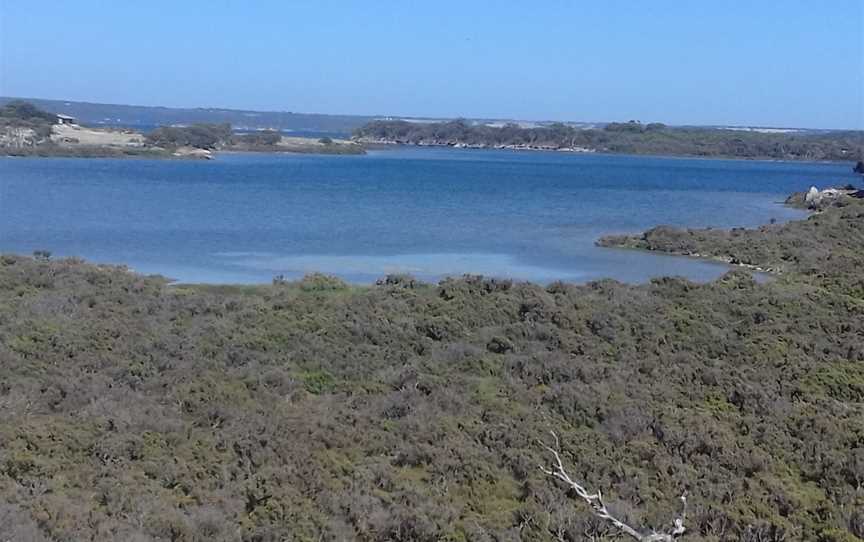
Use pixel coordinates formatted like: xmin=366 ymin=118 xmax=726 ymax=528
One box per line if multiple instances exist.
xmin=0 ymin=148 xmax=856 ymax=283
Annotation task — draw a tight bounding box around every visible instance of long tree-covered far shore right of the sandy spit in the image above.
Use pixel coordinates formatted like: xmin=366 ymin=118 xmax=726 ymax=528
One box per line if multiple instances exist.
xmin=354 ymin=120 xmax=864 ymax=161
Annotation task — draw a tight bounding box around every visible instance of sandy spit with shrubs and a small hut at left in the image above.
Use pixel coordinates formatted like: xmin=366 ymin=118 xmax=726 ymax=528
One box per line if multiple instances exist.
xmin=0 ymin=102 xmax=365 ymax=158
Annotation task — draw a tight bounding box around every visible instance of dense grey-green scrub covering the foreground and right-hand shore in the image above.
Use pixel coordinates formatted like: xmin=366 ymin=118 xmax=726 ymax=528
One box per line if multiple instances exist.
xmin=0 ymin=192 xmax=864 ymax=542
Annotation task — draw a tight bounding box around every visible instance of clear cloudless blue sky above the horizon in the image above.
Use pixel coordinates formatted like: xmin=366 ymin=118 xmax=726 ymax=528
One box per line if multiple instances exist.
xmin=0 ymin=0 xmax=864 ymax=129
